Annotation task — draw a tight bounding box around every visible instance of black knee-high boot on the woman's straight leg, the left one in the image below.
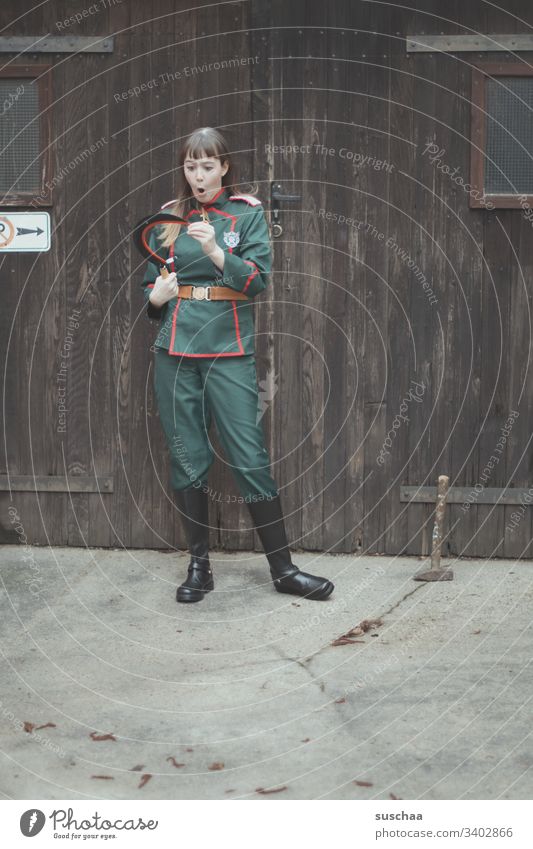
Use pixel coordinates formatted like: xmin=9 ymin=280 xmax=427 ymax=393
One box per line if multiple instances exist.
xmin=176 ymin=487 xmax=215 ymax=601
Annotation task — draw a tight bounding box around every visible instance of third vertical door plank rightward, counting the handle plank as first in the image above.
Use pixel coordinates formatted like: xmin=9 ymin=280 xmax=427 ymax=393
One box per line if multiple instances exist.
xmin=315 ymin=3 xmax=366 ymax=553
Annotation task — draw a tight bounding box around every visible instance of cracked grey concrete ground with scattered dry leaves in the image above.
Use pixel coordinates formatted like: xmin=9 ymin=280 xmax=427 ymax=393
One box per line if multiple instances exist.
xmin=0 ymin=545 xmax=533 ymax=799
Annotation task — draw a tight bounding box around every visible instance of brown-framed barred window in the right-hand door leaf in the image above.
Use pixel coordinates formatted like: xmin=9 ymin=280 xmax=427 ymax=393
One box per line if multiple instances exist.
xmin=470 ymin=62 xmax=533 ymax=207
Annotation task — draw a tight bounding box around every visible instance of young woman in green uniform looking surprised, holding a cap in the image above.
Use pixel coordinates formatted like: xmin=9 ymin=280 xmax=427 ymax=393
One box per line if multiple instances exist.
xmin=143 ymin=127 xmax=334 ymax=602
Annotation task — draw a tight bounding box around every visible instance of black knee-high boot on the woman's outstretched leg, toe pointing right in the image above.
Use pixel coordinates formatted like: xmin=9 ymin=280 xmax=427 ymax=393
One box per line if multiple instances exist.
xmin=247 ymin=495 xmax=334 ymax=601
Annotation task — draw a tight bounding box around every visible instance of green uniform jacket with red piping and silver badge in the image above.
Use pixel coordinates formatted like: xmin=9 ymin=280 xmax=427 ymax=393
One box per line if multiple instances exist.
xmin=142 ymin=186 xmax=272 ymax=357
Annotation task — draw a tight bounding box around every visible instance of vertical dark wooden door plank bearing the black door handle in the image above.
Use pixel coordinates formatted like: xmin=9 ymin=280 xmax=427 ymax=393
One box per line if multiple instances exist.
xmin=269 ymin=3 xmax=306 ymax=548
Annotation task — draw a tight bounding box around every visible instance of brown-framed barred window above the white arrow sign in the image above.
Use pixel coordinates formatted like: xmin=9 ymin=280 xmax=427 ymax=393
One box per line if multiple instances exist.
xmin=0 ymin=65 xmax=51 ymax=206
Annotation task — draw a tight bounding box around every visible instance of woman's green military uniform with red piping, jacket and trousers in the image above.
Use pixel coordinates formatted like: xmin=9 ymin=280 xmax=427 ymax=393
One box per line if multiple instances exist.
xmin=142 ymin=187 xmax=278 ymax=500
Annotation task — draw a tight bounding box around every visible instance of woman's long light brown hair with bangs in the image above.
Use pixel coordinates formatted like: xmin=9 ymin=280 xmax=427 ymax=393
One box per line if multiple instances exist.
xmin=159 ymin=127 xmax=257 ymax=248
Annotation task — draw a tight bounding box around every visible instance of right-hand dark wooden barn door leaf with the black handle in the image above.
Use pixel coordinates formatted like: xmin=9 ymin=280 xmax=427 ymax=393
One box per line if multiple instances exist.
xmin=251 ymin=0 xmax=531 ymax=557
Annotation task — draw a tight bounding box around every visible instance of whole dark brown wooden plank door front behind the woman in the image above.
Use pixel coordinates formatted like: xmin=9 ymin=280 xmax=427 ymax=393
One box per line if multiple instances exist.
xmin=0 ymin=0 xmax=533 ymax=558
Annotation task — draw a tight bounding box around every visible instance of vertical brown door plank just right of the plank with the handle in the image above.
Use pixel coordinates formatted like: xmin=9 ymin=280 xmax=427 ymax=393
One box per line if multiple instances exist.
xmin=298 ymin=6 xmax=326 ymax=551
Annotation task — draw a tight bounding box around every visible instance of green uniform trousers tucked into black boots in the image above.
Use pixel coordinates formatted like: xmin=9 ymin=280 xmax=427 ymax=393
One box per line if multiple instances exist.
xmin=154 ymin=346 xmax=279 ymax=501
